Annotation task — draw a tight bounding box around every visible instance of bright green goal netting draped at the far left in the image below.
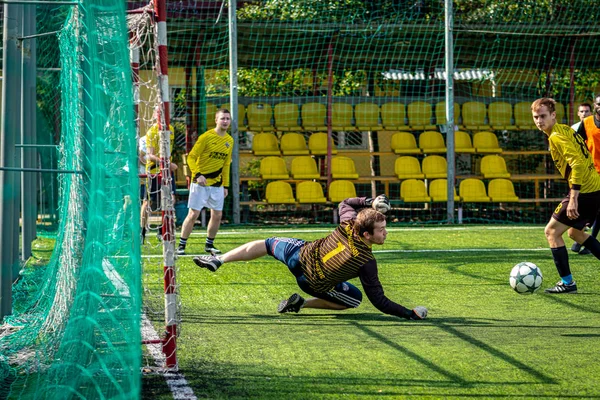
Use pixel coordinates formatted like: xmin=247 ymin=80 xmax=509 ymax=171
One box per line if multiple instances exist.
xmin=0 ymin=0 xmax=141 ymax=399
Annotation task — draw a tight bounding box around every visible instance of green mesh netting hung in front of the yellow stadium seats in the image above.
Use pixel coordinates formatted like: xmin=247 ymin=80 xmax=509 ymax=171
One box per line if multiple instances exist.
xmin=142 ymin=0 xmax=599 ymax=223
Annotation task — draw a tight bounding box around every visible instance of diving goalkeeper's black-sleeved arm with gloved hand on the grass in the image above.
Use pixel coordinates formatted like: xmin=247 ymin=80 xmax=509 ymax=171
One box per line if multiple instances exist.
xmin=358 ymin=260 xmax=427 ymax=319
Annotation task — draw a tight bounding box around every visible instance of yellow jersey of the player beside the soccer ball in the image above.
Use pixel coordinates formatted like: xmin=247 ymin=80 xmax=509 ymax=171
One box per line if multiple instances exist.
xmin=548 ymin=124 xmax=600 ymax=193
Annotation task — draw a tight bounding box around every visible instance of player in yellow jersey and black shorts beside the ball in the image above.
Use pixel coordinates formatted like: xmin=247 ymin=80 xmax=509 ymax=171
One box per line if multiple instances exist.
xmin=531 ymin=98 xmax=600 ymax=293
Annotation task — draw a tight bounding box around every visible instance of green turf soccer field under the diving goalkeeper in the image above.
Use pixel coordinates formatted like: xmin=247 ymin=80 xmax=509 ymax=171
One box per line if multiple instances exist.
xmin=143 ymin=226 xmax=600 ymax=399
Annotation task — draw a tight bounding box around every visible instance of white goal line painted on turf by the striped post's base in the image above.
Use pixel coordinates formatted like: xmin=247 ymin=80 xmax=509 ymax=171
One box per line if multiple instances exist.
xmin=102 ymin=256 xmax=197 ymax=400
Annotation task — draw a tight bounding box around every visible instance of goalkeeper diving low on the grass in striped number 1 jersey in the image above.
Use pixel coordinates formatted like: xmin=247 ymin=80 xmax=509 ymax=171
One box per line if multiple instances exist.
xmin=194 ymin=195 xmax=427 ymax=320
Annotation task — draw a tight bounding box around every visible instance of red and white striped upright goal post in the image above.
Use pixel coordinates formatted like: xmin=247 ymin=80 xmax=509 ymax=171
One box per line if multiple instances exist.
xmin=154 ymin=0 xmax=177 ymax=368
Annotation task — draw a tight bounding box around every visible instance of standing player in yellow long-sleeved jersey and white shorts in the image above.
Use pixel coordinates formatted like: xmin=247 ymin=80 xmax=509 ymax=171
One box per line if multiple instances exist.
xmin=177 ymin=109 xmax=233 ymax=255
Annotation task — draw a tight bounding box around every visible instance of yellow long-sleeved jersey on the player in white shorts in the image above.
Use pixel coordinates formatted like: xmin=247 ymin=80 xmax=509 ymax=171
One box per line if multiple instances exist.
xmin=187 ymin=129 xmax=233 ymax=187
